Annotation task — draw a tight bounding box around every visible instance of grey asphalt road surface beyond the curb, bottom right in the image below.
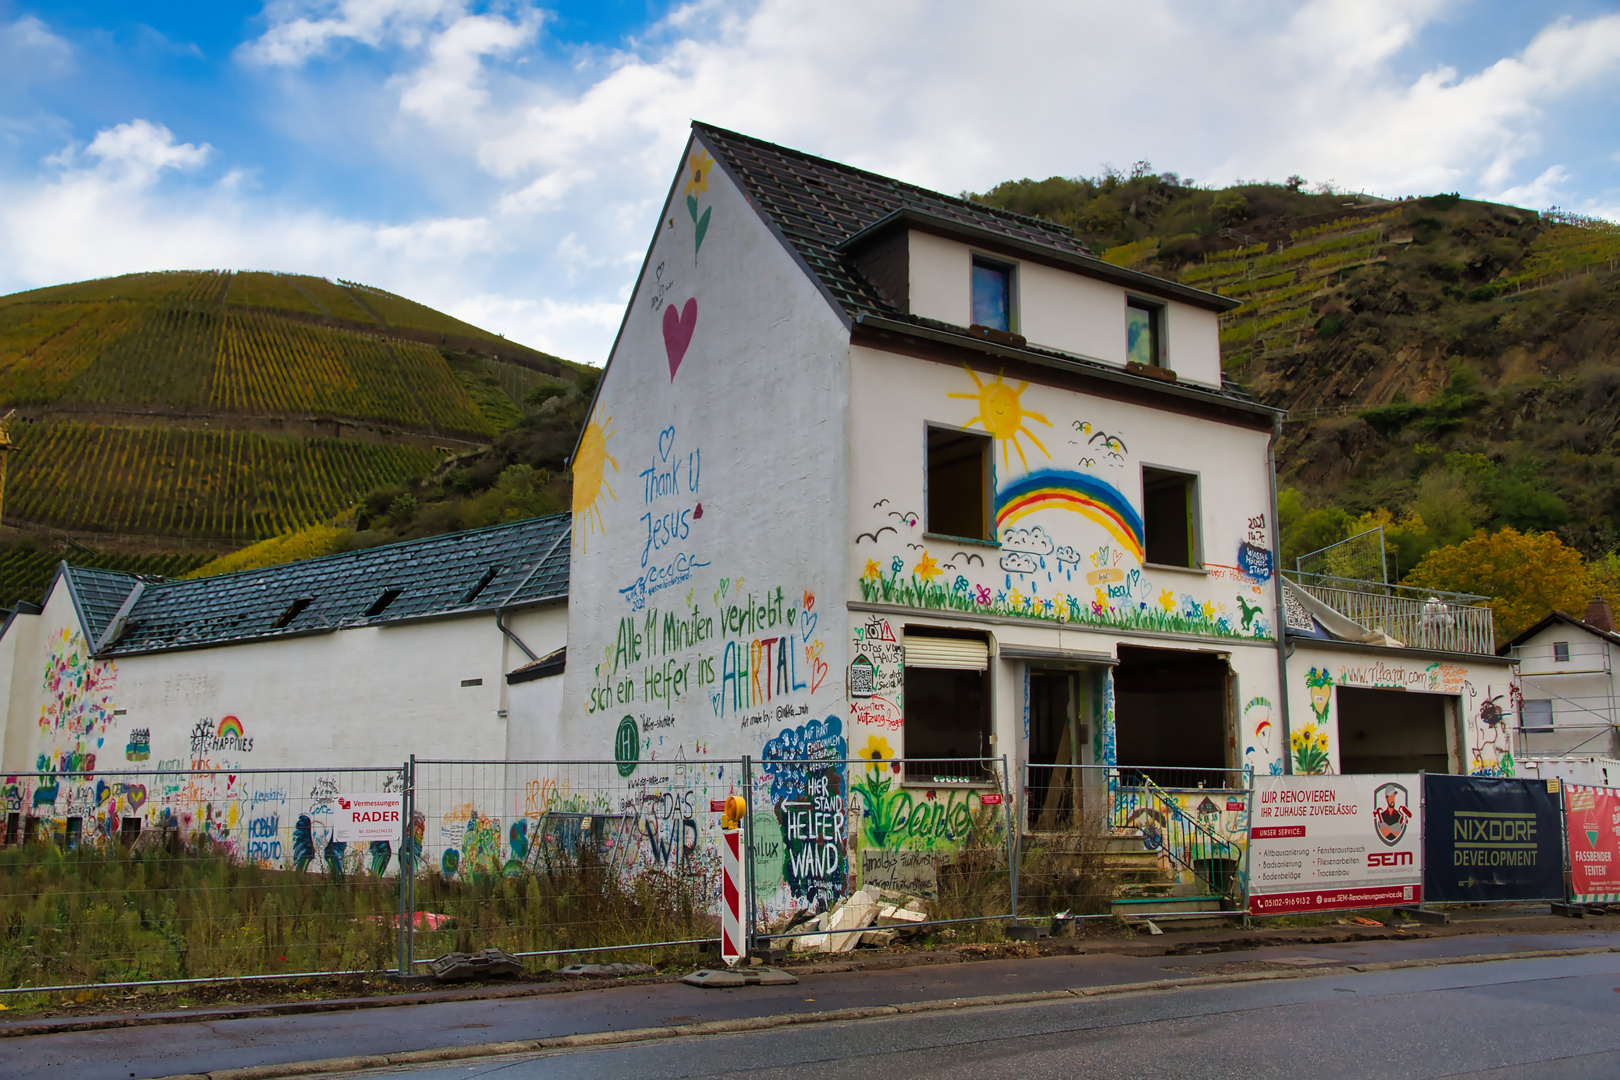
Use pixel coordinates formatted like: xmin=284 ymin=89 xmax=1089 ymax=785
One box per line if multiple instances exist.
xmin=319 ymin=954 xmax=1620 ymax=1080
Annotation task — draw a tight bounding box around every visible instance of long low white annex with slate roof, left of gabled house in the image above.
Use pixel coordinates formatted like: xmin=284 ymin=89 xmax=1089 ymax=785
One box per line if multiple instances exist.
xmin=0 ymin=515 xmax=570 ymax=842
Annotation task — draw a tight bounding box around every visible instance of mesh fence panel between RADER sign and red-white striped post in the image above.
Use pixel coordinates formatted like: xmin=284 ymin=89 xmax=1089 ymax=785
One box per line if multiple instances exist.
xmin=410 ymin=758 xmax=744 ymax=963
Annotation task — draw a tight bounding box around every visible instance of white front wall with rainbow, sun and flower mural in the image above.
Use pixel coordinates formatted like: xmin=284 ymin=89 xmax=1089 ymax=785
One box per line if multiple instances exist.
xmin=844 ymin=347 xmax=1281 ymax=772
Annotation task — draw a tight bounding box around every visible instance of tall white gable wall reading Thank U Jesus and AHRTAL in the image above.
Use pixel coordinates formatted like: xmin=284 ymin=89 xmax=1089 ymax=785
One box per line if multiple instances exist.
xmin=560 ymin=135 xmax=852 ymax=910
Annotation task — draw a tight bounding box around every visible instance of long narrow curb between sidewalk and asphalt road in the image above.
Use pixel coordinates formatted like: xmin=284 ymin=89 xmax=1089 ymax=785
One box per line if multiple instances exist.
xmin=160 ymin=946 xmax=1620 ymax=1080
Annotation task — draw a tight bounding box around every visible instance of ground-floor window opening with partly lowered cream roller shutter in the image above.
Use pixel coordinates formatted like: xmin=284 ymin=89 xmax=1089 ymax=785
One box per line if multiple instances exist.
xmin=904 ymin=631 xmax=990 ymax=780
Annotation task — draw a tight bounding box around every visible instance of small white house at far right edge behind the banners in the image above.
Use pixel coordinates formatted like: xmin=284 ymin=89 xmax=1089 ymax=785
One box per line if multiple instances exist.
xmin=1500 ymin=597 xmax=1620 ymax=785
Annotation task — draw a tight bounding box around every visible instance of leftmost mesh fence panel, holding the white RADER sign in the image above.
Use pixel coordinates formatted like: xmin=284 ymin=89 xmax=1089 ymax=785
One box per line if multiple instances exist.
xmin=0 ymin=767 xmax=405 ymax=993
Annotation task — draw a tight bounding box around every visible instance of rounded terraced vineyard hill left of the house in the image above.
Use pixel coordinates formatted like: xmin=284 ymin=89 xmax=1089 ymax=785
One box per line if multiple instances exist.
xmin=0 ymin=270 xmax=582 ymax=604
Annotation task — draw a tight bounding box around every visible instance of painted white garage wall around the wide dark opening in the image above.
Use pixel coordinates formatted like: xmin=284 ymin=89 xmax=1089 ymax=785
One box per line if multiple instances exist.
xmin=1288 ymin=641 xmax=1516 ymax=777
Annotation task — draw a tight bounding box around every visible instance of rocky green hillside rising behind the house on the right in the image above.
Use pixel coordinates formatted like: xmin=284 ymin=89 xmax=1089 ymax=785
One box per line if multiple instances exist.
xmin=970 ymin=172 xmax=1620 ymax=582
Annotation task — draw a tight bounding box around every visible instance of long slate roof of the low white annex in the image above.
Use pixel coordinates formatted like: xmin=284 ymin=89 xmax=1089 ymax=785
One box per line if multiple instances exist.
xmin=41 ymin=513 xmax=572 ymax=656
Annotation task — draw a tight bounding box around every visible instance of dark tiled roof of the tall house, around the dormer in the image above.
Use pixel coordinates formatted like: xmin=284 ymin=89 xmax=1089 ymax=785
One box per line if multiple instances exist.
xmin=692 ymin=121 xmax=1273 ymax=411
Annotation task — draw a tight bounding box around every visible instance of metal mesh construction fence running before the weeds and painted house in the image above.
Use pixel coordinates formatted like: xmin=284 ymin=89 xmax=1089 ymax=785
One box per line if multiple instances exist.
xmin=0 ymin=757 xmax=1614 ymax=993
